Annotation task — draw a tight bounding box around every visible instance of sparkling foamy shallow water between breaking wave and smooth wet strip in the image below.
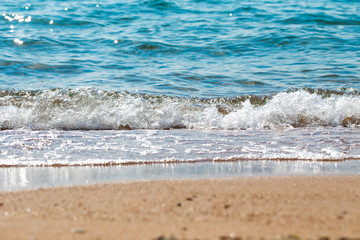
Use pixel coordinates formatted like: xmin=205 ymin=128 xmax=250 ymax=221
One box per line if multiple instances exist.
xmin=0 ymin=128 xmax=360 ymax=166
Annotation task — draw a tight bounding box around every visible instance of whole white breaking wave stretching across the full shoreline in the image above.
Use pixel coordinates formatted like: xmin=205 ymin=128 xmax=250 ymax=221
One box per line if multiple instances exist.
xmin=0 ymin=88 xmax=360 ymax=130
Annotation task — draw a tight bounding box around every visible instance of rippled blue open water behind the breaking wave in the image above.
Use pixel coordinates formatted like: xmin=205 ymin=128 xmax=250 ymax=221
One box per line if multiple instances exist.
xmin=0 ymin=0 xmax=360 ymax=98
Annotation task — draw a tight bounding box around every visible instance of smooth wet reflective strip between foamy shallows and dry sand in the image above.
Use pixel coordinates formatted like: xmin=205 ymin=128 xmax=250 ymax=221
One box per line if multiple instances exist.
xmin=0 ymin=160 xmax=360 ymax=191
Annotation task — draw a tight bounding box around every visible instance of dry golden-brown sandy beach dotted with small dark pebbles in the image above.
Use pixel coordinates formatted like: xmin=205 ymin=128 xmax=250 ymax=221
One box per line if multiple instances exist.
xmin=0 ymin=176 xmax=360 ymax=240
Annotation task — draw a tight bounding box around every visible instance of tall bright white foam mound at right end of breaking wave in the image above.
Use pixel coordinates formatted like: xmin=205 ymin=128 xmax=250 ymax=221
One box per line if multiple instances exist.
xmin=222 ymin=91 xmax=360 ymax=129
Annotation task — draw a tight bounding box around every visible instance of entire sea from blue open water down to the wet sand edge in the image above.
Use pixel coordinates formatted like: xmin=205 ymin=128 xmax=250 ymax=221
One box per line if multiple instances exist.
xmin=0 ymin=0 xmax=360 ymax=190
